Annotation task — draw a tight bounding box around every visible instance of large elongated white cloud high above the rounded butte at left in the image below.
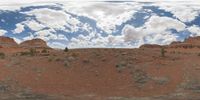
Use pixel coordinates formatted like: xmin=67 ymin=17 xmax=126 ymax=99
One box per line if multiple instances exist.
xmin=25 ymin=8 xmax=81 ymax=32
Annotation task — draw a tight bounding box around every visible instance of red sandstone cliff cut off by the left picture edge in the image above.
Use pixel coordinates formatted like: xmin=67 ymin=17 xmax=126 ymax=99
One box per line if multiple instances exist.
xmin=0 ymin=36 xmax=18 ymax=48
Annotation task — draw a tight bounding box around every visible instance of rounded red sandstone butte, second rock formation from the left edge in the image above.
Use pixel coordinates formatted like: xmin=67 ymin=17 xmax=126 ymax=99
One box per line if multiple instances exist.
xmin=20 ymin=39 xmax=49 ymax=48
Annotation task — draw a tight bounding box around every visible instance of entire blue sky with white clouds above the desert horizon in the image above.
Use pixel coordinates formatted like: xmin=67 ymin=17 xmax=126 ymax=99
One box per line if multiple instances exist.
xmin=0 ymin=0 xmax=200 ymax=48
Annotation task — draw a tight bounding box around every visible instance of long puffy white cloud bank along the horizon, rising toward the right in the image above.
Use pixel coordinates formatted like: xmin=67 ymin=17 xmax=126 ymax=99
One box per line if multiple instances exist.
xmin=69 ymin=16 xmax=186 ymax=48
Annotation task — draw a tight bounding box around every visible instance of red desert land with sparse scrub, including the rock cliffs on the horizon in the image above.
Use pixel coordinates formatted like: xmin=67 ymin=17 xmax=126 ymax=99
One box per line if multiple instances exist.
xmin=0 ymin=37 xmax=200 ymax=100
